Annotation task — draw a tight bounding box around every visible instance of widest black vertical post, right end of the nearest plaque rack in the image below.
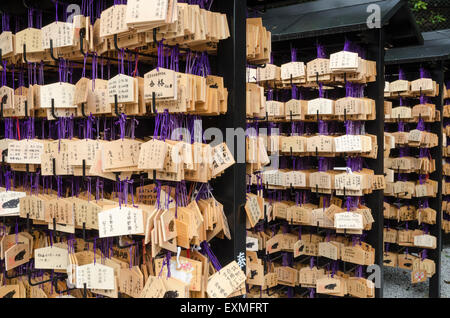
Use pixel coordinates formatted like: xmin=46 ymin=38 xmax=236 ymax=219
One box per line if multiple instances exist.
xmin=212 ymin=0 xmax=246 ymax=271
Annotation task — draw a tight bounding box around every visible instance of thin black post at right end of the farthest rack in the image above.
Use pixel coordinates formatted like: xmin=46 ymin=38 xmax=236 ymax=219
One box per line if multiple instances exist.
xmin=429 ymin=61 xmax=444 ymax=298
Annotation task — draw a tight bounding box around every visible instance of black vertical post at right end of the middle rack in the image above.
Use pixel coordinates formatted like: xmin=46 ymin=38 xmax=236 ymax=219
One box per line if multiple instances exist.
xmin=366 ymin=29 xmax=385 ymax=298
